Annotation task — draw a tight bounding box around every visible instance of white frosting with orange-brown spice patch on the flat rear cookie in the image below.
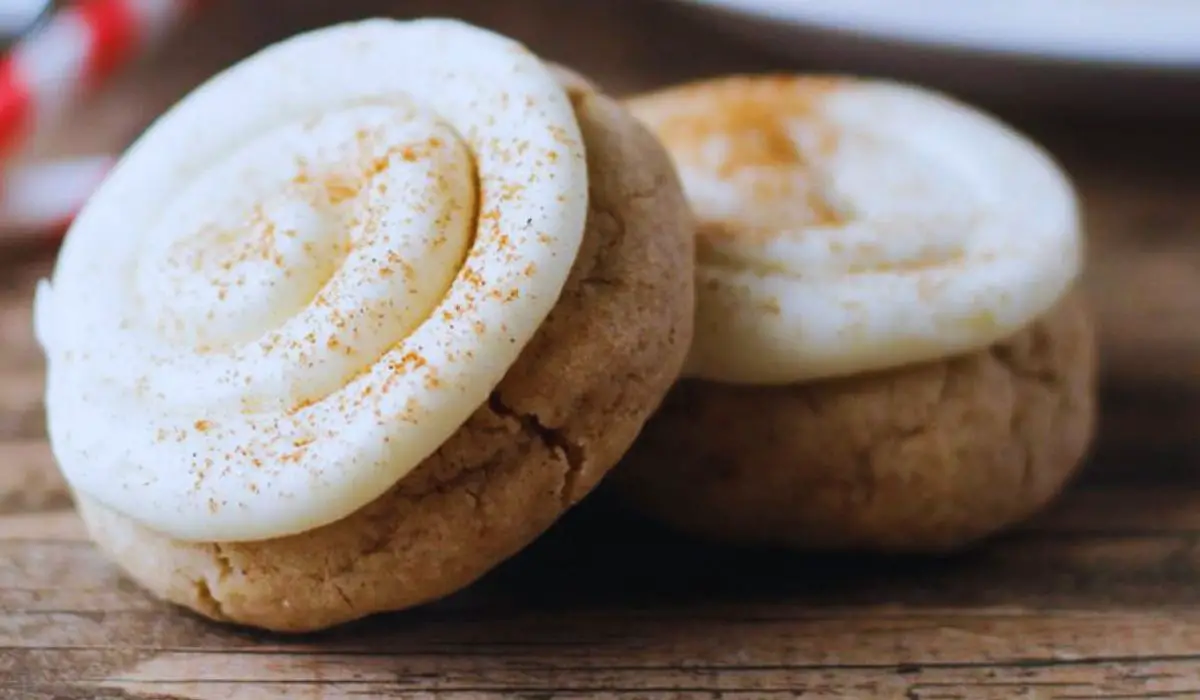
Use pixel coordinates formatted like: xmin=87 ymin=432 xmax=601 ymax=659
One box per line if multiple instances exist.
xmin=630 ymin=77 xmax=1082 ymax=384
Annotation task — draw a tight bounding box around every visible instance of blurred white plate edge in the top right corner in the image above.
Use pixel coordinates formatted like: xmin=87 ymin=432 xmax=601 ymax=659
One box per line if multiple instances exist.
xmin=679 ymin=0 xmax=1200 ymax=71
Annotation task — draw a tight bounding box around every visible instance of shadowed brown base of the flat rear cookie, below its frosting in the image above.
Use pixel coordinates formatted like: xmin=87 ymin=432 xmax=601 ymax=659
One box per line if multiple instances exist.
xmin=610 ymin=291 xmax=1096 ymax=552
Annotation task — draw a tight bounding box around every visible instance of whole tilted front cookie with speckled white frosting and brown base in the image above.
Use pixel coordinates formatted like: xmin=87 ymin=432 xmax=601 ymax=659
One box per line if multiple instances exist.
xmin=35 ymin=19 xmax=694 ymax=632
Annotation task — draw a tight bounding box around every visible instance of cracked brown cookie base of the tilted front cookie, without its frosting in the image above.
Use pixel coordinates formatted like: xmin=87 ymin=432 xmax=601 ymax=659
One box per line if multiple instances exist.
xmin=78 ymin=68 xmax=694 ymax=632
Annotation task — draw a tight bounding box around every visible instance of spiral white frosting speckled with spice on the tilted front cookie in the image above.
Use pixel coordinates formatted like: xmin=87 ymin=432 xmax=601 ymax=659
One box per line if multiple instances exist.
xmin=36 ymin=19 xmax=587 ymax=542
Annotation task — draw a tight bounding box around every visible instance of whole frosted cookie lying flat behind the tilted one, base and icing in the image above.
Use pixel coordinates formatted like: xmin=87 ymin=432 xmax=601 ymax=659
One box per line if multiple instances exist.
xmin=613 ymin=77 xmax=1096 ymax=551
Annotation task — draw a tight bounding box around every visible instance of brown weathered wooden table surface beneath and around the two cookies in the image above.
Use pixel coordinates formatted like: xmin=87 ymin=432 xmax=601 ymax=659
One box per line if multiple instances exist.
xmin=7 ymin=0 xmax=1200 ymax=700
